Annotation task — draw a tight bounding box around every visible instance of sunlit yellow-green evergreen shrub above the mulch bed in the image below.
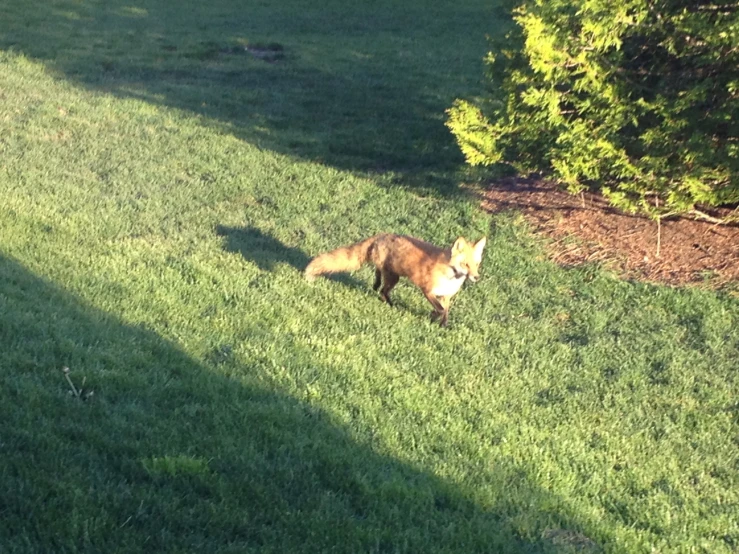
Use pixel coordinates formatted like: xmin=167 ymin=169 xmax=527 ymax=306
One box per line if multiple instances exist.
xmin=447 ymin=0 xmax=739 ymax=217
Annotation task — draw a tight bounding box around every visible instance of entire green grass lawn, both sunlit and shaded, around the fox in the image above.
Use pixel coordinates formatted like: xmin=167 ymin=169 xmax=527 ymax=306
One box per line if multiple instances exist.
xmin=0 ymin=0 xmax=739 ymax=554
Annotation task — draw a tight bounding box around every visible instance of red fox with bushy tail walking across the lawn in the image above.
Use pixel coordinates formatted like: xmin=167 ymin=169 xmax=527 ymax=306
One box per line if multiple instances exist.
xmin=305 ymin=234 xmax=485 ymax=327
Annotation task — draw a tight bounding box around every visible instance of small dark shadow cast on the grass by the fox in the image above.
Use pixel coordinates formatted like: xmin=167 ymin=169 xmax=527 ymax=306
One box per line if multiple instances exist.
xmin=216 ymin=225 xmax=372 ymax=291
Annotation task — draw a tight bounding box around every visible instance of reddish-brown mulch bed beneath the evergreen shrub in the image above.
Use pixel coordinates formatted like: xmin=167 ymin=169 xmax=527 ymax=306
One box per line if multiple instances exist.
xmin=482 ymin=177 xmax=739 ymax=288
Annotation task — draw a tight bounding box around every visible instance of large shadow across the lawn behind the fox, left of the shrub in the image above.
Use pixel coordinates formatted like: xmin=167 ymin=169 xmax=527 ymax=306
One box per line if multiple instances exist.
xmin=0 ymin=0 xmax=495 ymax=194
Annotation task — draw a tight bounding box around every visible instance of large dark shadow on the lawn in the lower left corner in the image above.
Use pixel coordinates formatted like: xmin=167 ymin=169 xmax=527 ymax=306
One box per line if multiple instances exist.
xmin=0 ymin=256 xmax=600 ymax=553
